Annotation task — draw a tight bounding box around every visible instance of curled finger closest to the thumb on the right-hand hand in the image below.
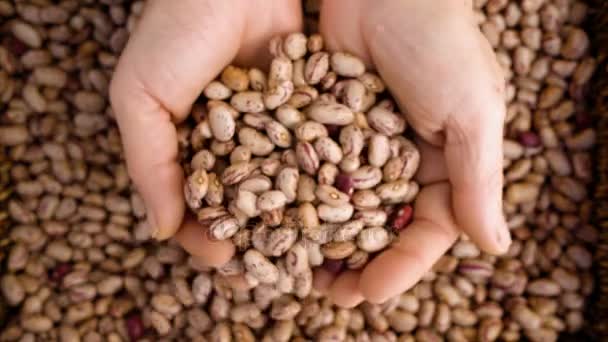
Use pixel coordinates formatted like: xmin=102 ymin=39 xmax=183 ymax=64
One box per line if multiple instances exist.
xmin=359 ymin=183 xmax=458 ymax=303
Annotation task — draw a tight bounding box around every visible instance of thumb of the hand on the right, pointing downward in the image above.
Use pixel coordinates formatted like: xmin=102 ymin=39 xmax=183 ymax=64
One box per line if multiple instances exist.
xmin=445 ymin=92 xmax=511 ymax=254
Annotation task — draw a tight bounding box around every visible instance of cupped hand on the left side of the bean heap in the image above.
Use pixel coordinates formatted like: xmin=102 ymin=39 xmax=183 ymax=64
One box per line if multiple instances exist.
xmin=110 ymin=0 xmax=302 ymax=266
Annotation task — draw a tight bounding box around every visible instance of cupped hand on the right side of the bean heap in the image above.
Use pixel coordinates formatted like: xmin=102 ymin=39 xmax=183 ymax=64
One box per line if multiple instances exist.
xmin=315 ymin=0 xmax=511 ymax=307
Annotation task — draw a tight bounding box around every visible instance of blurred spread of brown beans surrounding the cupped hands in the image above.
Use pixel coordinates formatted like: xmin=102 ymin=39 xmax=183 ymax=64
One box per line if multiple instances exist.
xmin=0 ymin=0 xmax=598 ymax=341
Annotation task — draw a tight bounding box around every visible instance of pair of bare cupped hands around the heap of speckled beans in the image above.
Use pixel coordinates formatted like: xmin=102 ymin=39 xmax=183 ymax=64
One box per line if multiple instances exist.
xmin=110 ymin=0 xmax=511 ymax=307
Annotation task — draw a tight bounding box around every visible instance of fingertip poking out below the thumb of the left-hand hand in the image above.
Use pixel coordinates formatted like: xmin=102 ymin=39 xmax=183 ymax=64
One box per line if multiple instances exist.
xmin=175 ymin=218 xmax=235 ymax=267
